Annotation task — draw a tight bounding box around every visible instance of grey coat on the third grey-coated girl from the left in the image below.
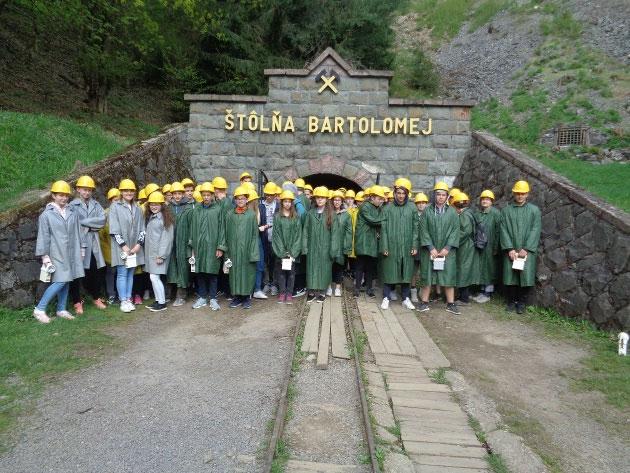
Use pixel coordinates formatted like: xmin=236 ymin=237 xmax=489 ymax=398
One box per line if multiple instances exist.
xmin=109 ymin=201 xmax=144 ymax=266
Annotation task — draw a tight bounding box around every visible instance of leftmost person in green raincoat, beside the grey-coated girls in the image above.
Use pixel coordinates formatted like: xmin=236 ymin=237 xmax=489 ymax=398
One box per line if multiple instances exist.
xmin=166 ymin=182 xmax=194 ymax=307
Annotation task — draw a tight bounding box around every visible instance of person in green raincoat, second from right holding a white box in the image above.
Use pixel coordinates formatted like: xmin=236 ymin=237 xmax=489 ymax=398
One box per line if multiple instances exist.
xmin=418 ymin=182 xmax=460 ymax=315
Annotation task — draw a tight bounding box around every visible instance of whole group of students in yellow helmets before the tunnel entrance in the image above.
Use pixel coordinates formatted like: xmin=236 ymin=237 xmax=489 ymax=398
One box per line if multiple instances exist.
xmin=33 ymin=172 xmax=540 ymax=323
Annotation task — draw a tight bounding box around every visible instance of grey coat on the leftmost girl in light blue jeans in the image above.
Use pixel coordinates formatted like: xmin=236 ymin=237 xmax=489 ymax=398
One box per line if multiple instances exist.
xmin=35 ymin=203 xmax=85 ymax=282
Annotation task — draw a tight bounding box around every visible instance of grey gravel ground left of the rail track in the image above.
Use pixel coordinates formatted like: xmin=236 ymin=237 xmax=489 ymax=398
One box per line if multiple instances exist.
xmin=0 ymin=301 xmax=297 ymax=473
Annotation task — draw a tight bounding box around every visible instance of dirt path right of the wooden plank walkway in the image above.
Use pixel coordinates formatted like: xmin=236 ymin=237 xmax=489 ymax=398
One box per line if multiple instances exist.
xmin=420 ymin=305 xmax=630 ymax=473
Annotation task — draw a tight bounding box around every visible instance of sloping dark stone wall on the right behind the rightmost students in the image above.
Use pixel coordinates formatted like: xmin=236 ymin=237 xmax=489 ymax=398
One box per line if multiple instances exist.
xmin=456 ymin=132 xmax=630 ymax=329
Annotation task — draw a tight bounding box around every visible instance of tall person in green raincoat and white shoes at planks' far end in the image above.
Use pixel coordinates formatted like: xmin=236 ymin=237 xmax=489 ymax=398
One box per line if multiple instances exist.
xmin=380 ymin=178 xmax=419 ymax=310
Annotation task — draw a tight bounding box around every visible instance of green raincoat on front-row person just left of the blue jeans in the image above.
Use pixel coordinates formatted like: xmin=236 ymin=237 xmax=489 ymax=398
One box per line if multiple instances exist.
xmin=225 ymin=209 xmax=260 ymax=296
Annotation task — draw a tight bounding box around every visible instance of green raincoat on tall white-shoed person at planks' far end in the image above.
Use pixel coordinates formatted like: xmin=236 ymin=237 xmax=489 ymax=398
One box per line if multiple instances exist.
xmin=380 ymin=199 xmax=419 ymax=284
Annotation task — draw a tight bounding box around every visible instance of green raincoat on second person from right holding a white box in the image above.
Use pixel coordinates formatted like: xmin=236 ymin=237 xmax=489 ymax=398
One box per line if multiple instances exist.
xmin=419 ymin=204 xmax=459 ymax=287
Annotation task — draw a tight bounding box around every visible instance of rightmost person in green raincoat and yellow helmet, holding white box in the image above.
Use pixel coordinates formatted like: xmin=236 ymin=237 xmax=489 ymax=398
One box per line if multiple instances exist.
xmin=500 ymin=181 xmax=542 ymax=314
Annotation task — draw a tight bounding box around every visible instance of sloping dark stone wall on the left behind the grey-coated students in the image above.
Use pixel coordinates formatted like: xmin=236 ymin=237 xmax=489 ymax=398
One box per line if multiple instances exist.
xmin=0 ymin=125 xmax=190 ymax=307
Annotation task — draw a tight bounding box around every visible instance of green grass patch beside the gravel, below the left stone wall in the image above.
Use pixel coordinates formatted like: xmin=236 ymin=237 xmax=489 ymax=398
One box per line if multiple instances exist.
xmin=0 ymin=302 xmax=138 ymax=451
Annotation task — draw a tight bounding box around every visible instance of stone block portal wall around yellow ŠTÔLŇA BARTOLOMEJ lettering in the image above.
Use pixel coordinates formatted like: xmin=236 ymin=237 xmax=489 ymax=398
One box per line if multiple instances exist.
xmin=186 ymin=49 xmax=473 ymax=190
